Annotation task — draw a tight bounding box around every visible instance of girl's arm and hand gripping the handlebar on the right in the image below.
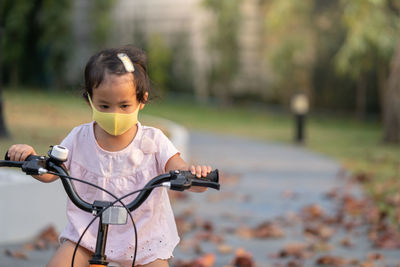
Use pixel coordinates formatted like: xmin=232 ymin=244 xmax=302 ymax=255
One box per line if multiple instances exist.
xmin=165 ymin=154 xmax=212 ymax=192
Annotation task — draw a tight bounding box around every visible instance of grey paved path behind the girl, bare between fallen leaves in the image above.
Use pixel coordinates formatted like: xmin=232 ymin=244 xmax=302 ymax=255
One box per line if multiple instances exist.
xmin=0 ymin=133 xmax=399 ymax=267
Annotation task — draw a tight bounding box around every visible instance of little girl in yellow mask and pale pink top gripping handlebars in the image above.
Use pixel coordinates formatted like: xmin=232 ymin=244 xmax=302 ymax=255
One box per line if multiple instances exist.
xmin=8 ymin=46 xmax=211 ymax=267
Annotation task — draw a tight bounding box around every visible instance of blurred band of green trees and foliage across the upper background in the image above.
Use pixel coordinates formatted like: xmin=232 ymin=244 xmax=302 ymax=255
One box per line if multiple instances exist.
xmin=0 ymin=0 xmax=400 ymax=142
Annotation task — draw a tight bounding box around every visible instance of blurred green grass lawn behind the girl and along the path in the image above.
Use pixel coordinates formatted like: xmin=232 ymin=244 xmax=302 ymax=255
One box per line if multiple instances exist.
xmin=0 ymin=90 xmax=400 ymax=223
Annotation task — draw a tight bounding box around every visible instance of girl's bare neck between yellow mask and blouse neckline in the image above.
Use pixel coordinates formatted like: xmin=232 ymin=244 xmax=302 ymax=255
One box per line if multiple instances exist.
xmin=94 ymin=123 xmax=138 ymax=152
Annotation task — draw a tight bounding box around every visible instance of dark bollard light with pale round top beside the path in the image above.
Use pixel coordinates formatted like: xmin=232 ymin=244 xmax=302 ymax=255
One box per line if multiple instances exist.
xmin=291 ymin=93 xmax=309 ymax=144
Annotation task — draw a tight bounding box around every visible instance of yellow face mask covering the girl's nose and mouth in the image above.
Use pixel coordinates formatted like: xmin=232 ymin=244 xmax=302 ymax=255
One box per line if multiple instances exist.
xmin=88 ymin=95 xmax=140 ymax=136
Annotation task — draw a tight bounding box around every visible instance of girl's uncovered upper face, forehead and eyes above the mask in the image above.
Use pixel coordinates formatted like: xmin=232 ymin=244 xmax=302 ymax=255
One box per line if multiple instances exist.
xmin=92 ymin=73 xmax=148 ymax=113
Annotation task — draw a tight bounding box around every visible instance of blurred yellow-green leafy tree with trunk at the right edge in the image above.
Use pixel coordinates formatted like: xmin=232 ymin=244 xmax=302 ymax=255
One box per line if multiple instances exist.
xmin=337 ymin=0 xmax=400 ymax=143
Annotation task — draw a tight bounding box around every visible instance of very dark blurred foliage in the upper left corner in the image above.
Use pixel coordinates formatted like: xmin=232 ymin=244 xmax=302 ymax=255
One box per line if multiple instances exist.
xmin=0 ymin=0 xmax=71 ymax=89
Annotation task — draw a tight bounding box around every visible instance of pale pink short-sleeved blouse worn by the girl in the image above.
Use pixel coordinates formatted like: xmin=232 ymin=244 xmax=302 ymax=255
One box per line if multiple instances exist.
xmin=60 ymin=122 xmax=179 ymax=266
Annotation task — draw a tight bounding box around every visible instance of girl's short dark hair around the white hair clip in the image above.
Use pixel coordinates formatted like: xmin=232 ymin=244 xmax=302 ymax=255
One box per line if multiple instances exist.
xmin=83 ymin=45 xmax=150 ymax=103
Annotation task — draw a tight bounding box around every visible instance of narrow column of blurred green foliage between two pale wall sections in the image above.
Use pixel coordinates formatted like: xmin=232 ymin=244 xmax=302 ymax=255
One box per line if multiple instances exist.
xmin=203 ymin=0 xmax=241 ymax=104
